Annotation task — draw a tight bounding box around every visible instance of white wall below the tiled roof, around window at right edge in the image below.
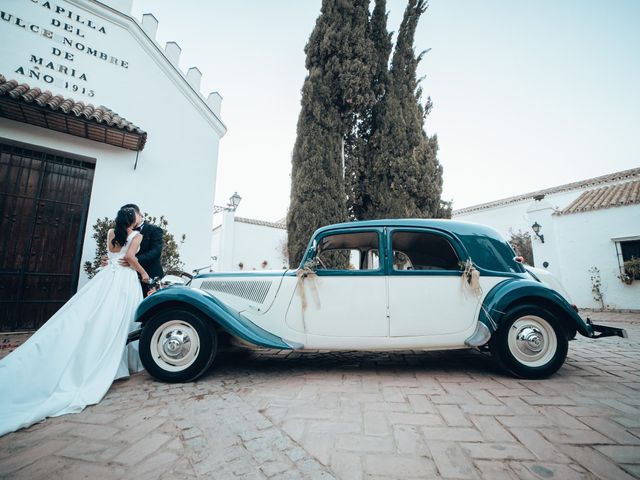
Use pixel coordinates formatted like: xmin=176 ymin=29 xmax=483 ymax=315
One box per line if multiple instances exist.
xmin=534 ymin=205 xmax=640 ymax=310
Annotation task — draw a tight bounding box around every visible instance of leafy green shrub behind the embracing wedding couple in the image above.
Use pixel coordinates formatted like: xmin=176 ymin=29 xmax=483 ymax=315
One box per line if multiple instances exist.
xmin=83 ymin=213 xmax=187 ymax=278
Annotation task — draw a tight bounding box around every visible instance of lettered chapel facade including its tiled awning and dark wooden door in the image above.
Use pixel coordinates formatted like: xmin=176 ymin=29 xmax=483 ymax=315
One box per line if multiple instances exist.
xmin=0 ymin=0 xmax=226 ymax=330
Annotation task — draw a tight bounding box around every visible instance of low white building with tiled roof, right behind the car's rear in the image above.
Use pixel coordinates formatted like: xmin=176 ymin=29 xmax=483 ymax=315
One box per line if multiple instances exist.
xmin=453 ymin=168 xmax=640 ymax=310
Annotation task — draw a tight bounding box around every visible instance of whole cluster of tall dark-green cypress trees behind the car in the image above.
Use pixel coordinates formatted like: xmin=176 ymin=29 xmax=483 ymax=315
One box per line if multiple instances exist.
xmin=287 ymin=0 xmax=451 ymax=267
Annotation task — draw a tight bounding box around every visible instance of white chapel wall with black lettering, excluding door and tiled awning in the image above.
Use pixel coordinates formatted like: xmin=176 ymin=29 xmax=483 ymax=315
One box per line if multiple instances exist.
xmin=0 ymin=0 xmax=225 ymax=285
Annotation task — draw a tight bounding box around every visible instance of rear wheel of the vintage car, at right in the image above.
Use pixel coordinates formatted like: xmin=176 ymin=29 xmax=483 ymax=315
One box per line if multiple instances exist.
xmin=489 ymin=305 xmax=569 ymax=379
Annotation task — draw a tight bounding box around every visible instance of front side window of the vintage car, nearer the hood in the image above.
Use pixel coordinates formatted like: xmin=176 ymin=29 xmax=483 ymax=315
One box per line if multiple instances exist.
xmin=316 ymin=232 xmax=380 ymax=270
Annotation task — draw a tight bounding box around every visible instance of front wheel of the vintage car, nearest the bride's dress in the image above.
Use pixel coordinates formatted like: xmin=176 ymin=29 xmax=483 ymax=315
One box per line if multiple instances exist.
xmin=139 ymin=308 xmax=218 ymax=382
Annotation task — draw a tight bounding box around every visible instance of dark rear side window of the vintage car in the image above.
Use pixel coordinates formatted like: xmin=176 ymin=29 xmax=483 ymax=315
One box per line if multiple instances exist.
xmin=391 ymin=232 xmax=460 ymax=270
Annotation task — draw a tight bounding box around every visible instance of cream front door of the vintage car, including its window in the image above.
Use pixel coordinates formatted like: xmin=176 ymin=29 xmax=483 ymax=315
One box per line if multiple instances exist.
xmin=287 ymin=228 xmax=389 ymax=338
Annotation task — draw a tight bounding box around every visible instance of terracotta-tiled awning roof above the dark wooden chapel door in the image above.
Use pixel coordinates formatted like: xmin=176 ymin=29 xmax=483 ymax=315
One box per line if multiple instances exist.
xmin=0 ymin=75 xmax=147 ymax=151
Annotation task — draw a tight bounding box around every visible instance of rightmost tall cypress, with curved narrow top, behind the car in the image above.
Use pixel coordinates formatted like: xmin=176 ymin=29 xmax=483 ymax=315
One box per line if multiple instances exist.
xmin=361 ymin=0 xmax=447 ymax=219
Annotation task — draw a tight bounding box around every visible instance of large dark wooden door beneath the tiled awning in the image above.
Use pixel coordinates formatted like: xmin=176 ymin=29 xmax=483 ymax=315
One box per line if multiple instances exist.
xmin=0 ymin=144 xmax=95 ymax=331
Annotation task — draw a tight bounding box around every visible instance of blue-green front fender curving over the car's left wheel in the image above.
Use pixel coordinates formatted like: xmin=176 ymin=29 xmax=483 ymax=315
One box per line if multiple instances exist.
xmin=135 ymin=286 xmax=293 ymax=350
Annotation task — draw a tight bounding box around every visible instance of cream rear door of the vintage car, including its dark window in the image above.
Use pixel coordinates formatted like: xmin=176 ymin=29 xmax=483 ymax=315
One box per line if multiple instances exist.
xmin=387 ymin=228 xmax=480 ymax=345
